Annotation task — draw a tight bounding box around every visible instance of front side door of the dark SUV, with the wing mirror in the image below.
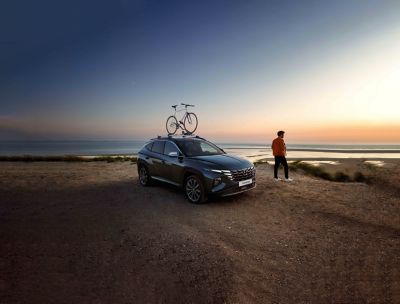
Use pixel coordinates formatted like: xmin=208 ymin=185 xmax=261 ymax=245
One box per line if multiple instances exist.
xmin=162 ymin=141 xmax=183 ymax=185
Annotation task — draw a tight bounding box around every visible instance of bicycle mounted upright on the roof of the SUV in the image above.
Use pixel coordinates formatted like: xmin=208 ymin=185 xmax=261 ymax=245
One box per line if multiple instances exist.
xmin=166 ymin=103 xmax=198 ymax=135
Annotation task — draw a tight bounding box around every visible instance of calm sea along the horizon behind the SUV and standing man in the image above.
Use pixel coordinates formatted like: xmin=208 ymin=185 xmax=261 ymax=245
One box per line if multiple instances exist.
xmin=0 ymin=140 xmax=400 ymax=161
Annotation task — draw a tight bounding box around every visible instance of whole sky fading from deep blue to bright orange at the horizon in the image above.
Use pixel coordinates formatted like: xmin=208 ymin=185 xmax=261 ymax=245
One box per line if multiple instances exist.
xmin=0 ymin=0 xmax=400 ymax=144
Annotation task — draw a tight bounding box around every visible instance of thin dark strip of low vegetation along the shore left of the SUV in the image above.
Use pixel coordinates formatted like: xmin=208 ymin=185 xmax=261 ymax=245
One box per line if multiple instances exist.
xmin=0 ymin=155 xmax=137 ymax=163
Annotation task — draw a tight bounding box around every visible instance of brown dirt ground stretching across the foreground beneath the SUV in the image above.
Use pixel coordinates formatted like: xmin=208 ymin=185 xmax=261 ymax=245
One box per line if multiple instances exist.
xmin=0 ymin=162 xmax=400 ymax=304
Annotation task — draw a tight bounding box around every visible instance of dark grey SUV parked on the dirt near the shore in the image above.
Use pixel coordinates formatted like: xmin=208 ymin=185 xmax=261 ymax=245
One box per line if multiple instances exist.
xmin=137 ymin=136 xmax=256 ymax=203
